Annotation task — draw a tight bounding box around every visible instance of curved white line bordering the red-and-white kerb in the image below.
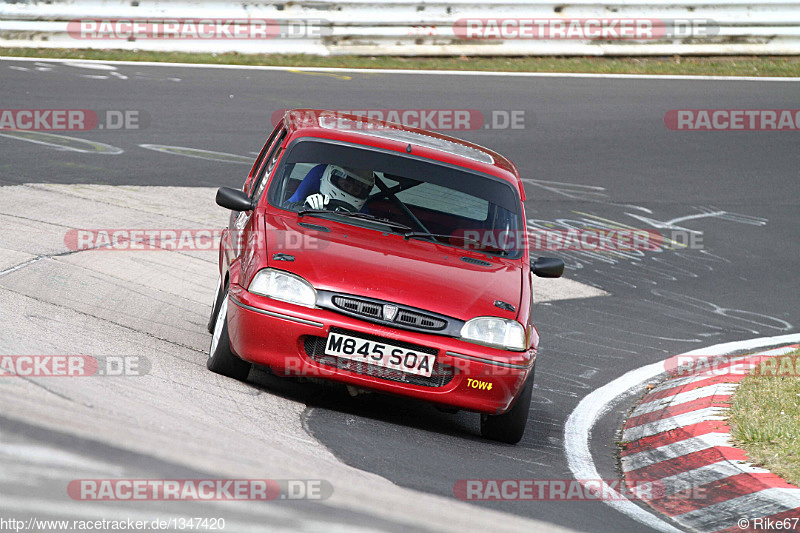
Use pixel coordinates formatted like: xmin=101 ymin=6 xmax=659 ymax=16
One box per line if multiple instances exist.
xmin=564 ymin=334 xmax=800 ymax=533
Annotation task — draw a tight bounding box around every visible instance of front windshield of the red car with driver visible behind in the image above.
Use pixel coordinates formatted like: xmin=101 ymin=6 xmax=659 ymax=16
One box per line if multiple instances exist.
xmin=267 ymin=138 xmax=524 ymax=257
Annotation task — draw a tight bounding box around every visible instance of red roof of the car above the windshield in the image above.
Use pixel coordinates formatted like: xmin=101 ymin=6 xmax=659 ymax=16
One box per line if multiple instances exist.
xmin=283 ymin=109 xmax=525 ymax=195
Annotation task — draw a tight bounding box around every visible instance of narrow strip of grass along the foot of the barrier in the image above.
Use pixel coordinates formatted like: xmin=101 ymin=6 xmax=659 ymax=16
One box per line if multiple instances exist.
xmin=0 ymin=48 xmax=800 ymax=76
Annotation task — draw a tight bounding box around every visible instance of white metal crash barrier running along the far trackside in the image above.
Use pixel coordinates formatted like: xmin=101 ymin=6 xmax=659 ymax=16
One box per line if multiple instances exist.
xmin=0 ymin=0 xmax=800 ymax=56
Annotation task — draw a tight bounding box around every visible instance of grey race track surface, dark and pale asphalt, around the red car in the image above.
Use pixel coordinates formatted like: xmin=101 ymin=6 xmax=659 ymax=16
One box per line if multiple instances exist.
xmin=0 ymin=60 xmax=800 ymax=532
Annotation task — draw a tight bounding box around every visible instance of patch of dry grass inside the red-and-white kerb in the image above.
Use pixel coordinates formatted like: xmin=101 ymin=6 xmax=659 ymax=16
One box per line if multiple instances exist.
xmin=729 ymin=350 xmax=800 ymax=485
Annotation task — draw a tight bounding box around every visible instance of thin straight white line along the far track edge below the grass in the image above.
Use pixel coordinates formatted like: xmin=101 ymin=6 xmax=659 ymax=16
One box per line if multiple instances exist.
xmin=0 ymin=56 xmax=800 ymax=82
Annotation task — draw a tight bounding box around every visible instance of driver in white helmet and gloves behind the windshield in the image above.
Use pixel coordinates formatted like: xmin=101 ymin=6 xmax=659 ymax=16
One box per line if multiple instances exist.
xmin=287 ymin=165 xmax=375 ymax=212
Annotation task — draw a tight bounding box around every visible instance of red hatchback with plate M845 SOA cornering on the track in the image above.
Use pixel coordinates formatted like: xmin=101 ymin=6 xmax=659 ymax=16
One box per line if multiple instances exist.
xmin=208 ymin=109 xmax=564 ymax=443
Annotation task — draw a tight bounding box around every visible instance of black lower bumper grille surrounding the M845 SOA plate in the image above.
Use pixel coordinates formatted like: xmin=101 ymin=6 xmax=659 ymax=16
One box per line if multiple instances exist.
xmin=304 ymin=328 xmax=455 ymax=387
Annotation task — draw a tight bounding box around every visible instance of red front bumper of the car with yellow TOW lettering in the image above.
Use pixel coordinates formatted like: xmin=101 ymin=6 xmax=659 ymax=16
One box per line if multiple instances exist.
xmin=228 ymin=285 xmax=536 ymax=414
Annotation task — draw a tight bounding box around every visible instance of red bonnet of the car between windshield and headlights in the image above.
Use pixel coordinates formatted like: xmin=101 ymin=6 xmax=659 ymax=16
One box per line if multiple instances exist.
xmin=265 ymin=216 xmax=522 ymax=320
